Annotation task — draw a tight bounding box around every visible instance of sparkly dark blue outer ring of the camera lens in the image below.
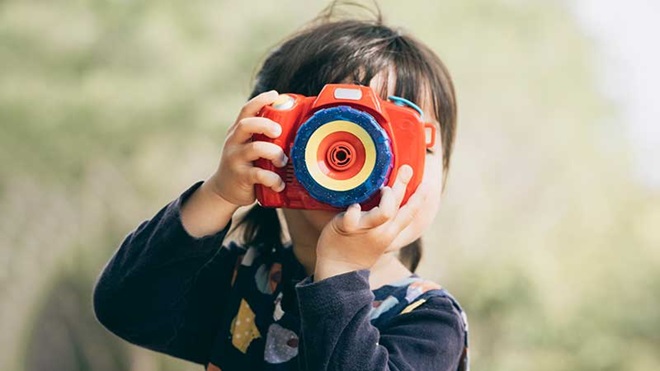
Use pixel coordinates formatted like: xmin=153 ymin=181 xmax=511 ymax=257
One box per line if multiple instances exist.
xmin=291 ymin=106 xmax=394 ymax=208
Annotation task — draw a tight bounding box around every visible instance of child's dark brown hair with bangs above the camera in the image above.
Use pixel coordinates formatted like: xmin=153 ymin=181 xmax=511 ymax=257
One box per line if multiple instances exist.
xmin=231 ymin=3 xmax=456 ymax=272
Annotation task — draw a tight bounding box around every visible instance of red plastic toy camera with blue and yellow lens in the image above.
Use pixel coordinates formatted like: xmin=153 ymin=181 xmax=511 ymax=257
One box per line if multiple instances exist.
xmin=253 ymin=84 xmax=436 ymax=210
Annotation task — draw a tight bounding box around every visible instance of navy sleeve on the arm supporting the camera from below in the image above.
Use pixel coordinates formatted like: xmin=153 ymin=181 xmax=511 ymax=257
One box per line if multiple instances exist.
xmin=296 ymin=271 xmax=464 ymax=371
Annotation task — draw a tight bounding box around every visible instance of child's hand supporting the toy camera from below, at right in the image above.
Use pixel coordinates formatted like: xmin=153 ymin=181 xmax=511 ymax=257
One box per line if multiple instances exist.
xmin=314 ymin=165 xmax=424 ymax=281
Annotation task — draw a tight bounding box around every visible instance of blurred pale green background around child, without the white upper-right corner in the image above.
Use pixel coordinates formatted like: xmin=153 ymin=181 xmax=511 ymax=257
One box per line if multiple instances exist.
xmin=0 ymin=0 xmax=660 ymax=371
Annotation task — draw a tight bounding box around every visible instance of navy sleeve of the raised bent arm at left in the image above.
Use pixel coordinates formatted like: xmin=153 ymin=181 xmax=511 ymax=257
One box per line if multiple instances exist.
xmin=94 ymin=183 xmax=237 ymax=364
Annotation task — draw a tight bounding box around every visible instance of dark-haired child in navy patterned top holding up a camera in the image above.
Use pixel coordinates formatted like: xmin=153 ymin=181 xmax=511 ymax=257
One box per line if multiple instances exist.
xmin=94 ymin=3 xmax=468 ymax=371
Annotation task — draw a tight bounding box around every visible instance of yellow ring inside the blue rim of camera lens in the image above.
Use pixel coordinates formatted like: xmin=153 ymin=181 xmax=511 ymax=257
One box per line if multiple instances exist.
xmin=305 ymin=120 xmax=376 ymax=191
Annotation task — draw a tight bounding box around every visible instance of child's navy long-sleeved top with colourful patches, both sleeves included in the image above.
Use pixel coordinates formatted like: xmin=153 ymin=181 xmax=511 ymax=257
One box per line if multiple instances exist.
xmin=94 ymin=184 xmax=468 ymax=371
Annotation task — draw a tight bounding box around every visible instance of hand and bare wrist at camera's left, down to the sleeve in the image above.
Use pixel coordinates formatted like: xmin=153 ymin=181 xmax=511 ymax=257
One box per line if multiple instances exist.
xmin=181 ymin=91 xmax=288 ymax=237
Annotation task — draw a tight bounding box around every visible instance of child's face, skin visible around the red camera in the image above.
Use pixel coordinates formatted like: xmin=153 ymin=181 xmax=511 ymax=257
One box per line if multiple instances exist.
xmin=284 ymin=75 xmax=443 ymax=251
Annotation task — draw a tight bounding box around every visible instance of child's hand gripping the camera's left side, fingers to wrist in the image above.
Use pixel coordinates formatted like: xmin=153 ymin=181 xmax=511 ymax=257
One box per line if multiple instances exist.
xmin=207 ymin=90 xmax=288 ymax=206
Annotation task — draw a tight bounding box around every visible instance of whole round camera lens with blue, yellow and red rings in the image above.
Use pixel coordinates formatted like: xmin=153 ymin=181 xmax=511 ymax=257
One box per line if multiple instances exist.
xmin=291 ymin=106 xmax=393 ymax=207
